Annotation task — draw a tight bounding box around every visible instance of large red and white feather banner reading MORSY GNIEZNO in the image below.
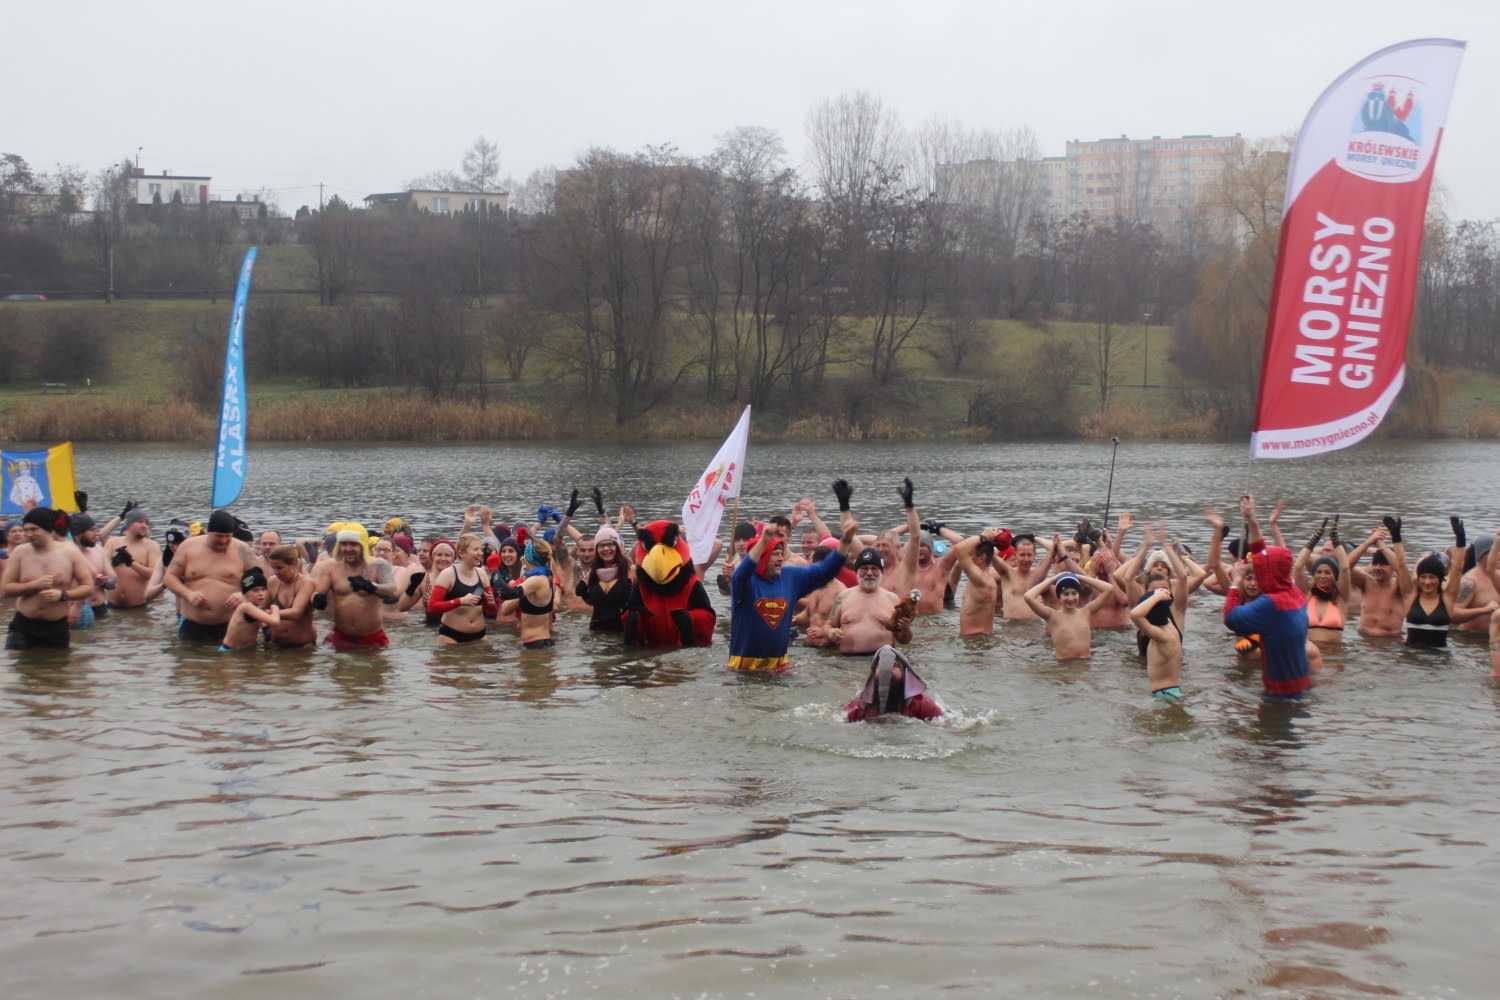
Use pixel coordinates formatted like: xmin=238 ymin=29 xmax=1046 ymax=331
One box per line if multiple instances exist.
xmin=1250 ymin=39 xmax=1464 ymax=459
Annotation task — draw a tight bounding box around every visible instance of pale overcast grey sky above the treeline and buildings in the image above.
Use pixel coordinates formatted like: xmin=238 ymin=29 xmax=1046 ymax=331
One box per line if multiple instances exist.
xmin=0 ymin=0 xmax=1500 ymax=219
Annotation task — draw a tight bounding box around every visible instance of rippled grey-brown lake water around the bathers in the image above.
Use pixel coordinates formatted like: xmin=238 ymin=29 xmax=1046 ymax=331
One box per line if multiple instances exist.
xmin=0 ymin=441 xmax=1500 ymax=1000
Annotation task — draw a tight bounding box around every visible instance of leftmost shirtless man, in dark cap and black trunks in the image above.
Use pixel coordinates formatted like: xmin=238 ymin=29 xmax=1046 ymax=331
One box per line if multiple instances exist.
xmin=0 ymin=507 xmax=95 ymax=649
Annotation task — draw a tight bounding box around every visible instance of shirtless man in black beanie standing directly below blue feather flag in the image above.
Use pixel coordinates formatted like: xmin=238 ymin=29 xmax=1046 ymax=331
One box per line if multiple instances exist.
xmin=164 ymin=510 xmax=255 ymax=646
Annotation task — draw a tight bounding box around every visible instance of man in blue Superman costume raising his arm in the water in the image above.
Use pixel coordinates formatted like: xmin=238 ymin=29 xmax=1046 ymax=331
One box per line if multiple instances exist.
xmin=729 ymin=517 xmax=860 ymax=673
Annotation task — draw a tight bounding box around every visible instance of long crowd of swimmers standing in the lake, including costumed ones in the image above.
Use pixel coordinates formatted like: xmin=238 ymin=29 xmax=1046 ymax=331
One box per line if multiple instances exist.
xmin=0 ymin=478 xmax=1500 ymax=721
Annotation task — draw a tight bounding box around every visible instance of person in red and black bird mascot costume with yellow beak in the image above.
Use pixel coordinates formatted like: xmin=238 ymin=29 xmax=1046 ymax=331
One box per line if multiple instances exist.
xmin=620 ymin=520 xmax=719 ymax=649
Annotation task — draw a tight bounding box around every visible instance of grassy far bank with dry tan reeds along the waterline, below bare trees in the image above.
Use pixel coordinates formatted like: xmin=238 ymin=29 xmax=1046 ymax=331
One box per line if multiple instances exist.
xmin=0 ymin=300 xmax=1500 ymax=442
